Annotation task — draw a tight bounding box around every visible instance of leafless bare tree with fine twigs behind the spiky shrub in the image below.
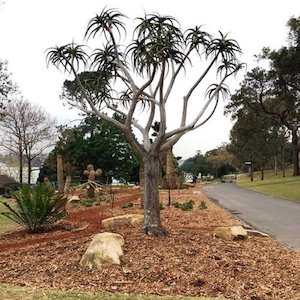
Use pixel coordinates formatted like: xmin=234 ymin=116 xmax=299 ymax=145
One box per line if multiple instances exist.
xmin=0 ymin=99 xmax=56 ymax=184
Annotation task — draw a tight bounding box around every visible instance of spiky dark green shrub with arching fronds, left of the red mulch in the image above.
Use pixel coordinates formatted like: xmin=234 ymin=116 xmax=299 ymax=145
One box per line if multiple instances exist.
xmin=0 ymin=184 xmax=67 ymax=232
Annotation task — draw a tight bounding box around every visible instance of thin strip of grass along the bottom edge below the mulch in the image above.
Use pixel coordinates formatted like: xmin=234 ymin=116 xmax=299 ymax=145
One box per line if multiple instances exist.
xmin=0 ymin=284 xmax=225 ymax=300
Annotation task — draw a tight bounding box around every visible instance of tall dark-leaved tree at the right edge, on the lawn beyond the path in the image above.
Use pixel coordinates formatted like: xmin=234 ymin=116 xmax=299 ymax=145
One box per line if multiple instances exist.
xmin=228 ymin=18 xmax=300 ymax=176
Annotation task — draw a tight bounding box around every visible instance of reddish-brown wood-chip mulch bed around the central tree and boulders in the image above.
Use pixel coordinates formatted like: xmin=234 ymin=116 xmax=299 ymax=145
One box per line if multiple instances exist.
xmin=0 ymin=186 xmax=300 ymax=300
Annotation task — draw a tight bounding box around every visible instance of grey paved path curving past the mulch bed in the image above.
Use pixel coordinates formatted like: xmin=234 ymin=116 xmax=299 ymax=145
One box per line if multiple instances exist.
xmin=203 ymin=183 xmax=300 ymax=251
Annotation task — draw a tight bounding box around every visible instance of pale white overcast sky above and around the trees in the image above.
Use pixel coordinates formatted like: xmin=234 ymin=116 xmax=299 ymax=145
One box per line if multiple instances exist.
xmin=0 ymin=0 xmax=300 ymax=159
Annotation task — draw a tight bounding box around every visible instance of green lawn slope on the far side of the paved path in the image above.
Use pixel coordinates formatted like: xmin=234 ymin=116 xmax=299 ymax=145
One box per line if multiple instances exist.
xmin=237 ymin=170 xmax=300 ymax=202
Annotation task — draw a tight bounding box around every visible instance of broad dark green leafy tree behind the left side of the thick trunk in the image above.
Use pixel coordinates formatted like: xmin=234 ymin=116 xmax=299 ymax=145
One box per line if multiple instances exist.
xmin=40 ymin=117 xmax=139 ymax=182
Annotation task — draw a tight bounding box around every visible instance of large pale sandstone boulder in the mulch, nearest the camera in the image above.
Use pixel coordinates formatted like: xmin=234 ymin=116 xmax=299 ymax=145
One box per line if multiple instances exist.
xmin=79 ymin=232 xmax=124 ymax=269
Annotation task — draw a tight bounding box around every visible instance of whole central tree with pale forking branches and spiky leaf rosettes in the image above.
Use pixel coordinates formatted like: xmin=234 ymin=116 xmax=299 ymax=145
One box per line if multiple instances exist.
xmin=47 ymin=9 xmax=241 ymax=236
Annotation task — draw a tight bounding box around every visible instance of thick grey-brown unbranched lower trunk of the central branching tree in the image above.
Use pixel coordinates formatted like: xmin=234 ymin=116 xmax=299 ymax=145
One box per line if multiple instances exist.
xmin=143 ymin=153 xmax=167 ymax=236
